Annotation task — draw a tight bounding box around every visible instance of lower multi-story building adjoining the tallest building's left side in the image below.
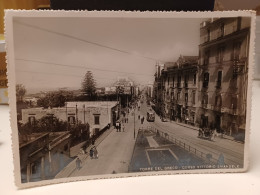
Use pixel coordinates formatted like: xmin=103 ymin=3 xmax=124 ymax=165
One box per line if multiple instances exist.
xmin=161 ymin=56 xmax=198 ymax=125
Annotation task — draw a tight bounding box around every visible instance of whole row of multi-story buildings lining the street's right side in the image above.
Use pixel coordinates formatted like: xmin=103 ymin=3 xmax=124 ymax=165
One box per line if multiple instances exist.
xmin=153 ymin=17 xmax=250 ymax=139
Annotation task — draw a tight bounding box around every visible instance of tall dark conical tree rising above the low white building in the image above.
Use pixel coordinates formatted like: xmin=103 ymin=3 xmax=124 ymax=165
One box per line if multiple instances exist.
xmin=82 ymin=71 xmax=96 ymax=100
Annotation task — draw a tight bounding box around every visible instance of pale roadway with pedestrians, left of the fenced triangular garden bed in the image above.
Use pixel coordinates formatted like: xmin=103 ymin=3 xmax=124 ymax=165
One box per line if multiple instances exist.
xmin=70 ymin=109 xmax=140 ymax=177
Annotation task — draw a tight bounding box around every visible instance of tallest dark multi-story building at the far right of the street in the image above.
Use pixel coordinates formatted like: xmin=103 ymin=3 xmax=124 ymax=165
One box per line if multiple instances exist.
xmin=197 ymin=17 xmax=250 ymax=137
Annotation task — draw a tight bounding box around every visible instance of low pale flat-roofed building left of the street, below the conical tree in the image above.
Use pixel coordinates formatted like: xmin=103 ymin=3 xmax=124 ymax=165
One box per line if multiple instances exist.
xmin=21 ymin=101 xmax=119 ymax=136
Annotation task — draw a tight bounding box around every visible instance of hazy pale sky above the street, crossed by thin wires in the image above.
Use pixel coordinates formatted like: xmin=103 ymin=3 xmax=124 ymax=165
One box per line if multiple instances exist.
xmin=14 ymin=17 xmax=201 ymax=91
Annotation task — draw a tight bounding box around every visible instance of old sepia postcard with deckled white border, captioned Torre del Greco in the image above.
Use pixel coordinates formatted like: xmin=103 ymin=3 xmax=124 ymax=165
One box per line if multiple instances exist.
xmin=5 ymin=10 xmax=255 ymax=188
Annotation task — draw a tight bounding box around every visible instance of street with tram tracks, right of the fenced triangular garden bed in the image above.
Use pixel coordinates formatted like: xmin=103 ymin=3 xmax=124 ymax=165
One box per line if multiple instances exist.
xmin=140 ymin=95 xmax=244 ymax=167
